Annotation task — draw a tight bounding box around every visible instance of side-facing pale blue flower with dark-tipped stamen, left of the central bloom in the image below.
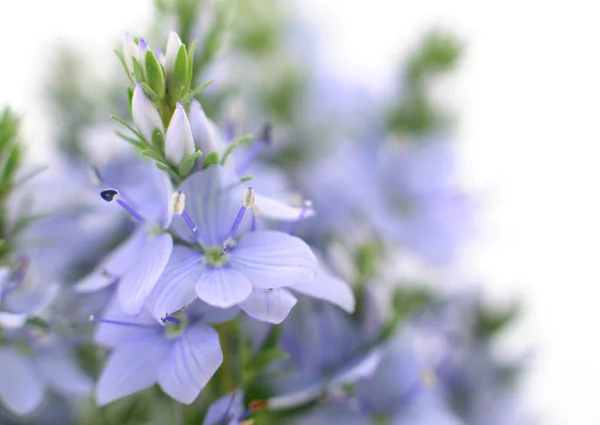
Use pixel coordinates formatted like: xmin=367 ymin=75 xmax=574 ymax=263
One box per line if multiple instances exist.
xmin=75 ymin=161 xmax=173 ymax=314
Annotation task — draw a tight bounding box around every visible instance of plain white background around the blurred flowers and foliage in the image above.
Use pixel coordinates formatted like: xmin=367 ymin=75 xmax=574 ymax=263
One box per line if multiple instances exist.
xmin=0 ymin=0 xmax=600 ymax=425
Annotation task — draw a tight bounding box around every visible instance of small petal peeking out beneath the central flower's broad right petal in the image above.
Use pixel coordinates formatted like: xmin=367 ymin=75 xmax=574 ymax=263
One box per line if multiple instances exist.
xmin=240 ymin=288 xmax=298 ymax=324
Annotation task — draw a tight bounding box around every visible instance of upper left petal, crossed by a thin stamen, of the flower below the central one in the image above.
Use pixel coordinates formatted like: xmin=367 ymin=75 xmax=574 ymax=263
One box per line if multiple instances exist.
xmin=94 ymin=300 xmax=164 ymax=347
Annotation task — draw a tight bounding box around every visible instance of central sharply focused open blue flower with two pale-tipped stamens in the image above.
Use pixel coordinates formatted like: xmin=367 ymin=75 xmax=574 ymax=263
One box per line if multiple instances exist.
xmin=148 ymin=165 xmax=317 ymax=320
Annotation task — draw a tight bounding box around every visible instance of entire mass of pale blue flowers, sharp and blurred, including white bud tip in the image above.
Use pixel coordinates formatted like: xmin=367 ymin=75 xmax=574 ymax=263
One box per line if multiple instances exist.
xmin=0 ymin=4 xmax=528 ymax=425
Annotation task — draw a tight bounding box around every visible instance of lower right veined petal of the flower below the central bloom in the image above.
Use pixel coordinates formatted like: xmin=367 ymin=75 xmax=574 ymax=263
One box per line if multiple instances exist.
xmin=158 ymin=323 xmax=223 ymax=404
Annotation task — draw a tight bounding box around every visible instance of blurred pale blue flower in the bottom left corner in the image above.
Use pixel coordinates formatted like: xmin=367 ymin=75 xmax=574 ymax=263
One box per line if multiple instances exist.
xmin=0 ymin=328 xmax=92 ymax=415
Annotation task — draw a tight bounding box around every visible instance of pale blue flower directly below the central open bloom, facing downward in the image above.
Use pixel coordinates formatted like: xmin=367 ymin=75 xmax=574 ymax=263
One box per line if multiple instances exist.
xmin=90 ymin=295 xmax=232 ymax=405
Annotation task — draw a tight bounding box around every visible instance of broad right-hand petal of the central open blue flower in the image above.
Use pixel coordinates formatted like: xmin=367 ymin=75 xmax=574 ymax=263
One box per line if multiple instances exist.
xmin=229 ymin=231 xmax=317 ymax=289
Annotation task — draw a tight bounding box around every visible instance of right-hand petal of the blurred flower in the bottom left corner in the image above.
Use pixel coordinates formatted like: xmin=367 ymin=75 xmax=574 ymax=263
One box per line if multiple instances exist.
xmin=35 ymin=347 xmax=93 ymax=396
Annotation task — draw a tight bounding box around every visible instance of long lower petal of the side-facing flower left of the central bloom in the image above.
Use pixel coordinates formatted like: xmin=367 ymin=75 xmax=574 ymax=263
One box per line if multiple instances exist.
xmin=118 ymin=229 xmax=173 ymax=314
